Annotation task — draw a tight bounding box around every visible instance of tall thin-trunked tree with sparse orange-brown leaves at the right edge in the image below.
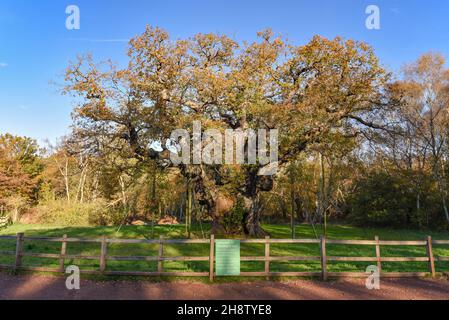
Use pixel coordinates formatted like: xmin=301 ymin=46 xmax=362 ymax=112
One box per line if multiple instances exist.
xmin=384 ymin=53 xmax=449 ymax=222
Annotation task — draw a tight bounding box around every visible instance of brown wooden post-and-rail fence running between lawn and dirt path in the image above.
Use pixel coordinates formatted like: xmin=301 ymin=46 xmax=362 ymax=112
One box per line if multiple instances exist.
xmin=0 ymin=233 xmax=449 ymax=281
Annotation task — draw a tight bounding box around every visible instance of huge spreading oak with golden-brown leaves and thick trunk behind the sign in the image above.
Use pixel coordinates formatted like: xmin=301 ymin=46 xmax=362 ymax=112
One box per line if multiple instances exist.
xmin=65 ymin=27 xmax=388 ymax=236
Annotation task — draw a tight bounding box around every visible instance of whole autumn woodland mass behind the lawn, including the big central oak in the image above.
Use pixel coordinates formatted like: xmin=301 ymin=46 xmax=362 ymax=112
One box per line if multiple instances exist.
xmin=0 ymin=28 xmax=449 ymax=235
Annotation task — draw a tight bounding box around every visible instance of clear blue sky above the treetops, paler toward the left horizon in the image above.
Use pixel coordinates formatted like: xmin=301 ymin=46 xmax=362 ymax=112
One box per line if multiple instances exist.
xmin=0 ymin=0 xmax=449 ymax=142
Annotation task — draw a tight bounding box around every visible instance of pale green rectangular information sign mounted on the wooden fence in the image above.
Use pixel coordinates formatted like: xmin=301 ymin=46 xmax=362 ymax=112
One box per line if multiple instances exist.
xmin=215 ymin=240 xmax=240 ymax=276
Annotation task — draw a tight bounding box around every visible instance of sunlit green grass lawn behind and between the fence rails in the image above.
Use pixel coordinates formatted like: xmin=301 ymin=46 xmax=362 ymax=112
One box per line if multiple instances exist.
xmin=0 ymin=224 xmax=449 ymax=278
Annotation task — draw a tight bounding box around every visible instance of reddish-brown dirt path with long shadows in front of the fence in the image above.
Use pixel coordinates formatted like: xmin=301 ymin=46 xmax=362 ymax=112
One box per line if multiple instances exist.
xmin=0 ymin=273 xmax=449 ymax=300
